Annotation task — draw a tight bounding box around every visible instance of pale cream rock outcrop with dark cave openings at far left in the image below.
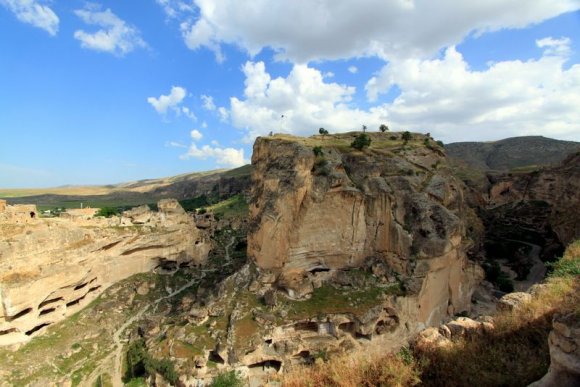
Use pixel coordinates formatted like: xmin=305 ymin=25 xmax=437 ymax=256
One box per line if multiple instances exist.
xmin=0 ymin=199 xmax=209 ymax=345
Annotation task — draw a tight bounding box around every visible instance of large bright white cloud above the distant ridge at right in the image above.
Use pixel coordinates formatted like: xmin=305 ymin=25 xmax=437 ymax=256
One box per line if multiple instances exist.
xmin=366 ymin=37 xmax=580 ymax=141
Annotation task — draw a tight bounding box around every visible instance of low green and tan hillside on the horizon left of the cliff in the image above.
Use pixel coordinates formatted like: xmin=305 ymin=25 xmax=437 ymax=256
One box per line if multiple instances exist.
xmin=0 ymin=165 xmax=251 ymax=209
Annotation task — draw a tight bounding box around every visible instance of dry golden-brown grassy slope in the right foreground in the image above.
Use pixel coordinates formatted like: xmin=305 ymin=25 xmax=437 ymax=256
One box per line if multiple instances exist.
xmin=283 ymin=241 xmax=580 ymax=387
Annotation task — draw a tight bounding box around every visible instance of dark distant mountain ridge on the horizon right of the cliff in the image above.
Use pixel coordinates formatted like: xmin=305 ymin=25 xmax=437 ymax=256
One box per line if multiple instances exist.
xmin=445 ymin=136 xmax=580 ymax=171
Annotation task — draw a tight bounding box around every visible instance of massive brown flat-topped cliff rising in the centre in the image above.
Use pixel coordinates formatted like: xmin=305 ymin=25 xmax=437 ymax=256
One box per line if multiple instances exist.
xmin=248 ymin=133 xmax=482 ymax=325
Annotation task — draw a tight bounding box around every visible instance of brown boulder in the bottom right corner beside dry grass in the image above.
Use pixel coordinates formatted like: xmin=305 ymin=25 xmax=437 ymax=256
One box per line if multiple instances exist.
xmin=530 ymin=313 xmax=580 ymax=387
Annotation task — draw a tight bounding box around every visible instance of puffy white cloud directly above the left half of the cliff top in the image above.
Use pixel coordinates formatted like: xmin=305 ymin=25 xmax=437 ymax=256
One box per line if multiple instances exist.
xmin=230 ymin=62 xmax=387 ymax=141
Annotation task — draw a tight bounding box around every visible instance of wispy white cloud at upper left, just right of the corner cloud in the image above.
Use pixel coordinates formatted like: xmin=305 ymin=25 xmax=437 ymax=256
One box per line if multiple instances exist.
xmin=74 ymin=5 xmax=147 ymax=55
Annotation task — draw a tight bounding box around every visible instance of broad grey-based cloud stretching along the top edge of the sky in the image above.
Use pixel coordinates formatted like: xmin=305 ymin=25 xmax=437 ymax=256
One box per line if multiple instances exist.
xmin=181 ymin=0 xmax=580 ymax=63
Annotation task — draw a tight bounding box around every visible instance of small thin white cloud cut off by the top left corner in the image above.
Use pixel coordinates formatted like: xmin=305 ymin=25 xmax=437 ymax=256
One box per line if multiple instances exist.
xmin=0 ymin=0 xmax=60 ymax=38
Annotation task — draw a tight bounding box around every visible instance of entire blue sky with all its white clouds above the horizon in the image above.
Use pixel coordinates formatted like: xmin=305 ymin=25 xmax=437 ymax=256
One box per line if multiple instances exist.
xmin=0 ymin=0 xmax=580 ymax=188
